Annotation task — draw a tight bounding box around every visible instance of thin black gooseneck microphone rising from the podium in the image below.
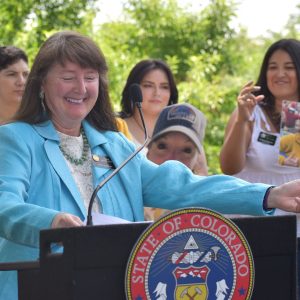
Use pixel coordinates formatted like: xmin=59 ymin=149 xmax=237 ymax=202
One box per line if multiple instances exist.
xmin=86 ymin=83 xmax=149 ymax=226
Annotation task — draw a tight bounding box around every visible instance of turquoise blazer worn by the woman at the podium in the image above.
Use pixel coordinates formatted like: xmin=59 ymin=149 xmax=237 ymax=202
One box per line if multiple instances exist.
xmin=0 ymin=121 xmax=268 ymax=300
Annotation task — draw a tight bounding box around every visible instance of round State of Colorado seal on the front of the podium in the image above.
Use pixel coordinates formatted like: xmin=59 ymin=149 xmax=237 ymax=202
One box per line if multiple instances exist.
xmin=125 ymin=208 xmax=254 ymax=300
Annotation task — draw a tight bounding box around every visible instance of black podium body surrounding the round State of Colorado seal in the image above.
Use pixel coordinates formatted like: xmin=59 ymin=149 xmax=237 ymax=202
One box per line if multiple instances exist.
xmin=0 ymin=216 xmax=297 ymax=300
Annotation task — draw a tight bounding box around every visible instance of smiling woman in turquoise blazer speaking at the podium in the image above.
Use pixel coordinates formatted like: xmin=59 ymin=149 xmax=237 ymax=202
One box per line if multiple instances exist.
xmin=0 ymin=32 xmax=300 ymax=300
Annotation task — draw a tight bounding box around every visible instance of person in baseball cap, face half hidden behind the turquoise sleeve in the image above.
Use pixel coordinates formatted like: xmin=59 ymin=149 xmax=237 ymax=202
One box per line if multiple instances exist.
xmin=144 ymin=103 xmax=208 ymax=220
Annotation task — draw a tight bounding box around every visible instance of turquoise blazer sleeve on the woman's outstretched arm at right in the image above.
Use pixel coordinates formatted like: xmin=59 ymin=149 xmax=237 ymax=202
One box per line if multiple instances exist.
xmin=141 ymin=159 xmax=274 ymax=215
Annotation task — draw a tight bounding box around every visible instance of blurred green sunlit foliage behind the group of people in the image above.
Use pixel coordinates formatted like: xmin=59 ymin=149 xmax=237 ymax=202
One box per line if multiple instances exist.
xmin=0 ymin=0 xmax=300 ymax=174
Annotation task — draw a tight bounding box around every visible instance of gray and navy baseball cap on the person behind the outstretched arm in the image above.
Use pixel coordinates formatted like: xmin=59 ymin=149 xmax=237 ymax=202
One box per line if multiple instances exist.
xmin=150 ymin=103 xmax=206 ymax=151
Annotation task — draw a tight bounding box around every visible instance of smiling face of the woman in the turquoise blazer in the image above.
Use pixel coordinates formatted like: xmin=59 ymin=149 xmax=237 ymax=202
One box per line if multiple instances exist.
xmin=42 ymin=62 xmax=99 ymax=135
